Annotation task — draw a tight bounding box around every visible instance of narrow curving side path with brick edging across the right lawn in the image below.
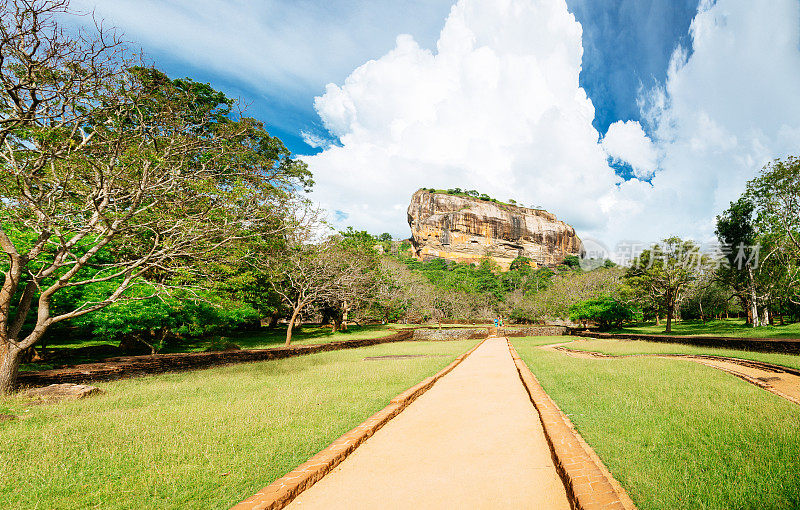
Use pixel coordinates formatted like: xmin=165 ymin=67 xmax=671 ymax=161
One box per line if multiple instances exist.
xmin=542 ymin=342 xmax=800 ymax=404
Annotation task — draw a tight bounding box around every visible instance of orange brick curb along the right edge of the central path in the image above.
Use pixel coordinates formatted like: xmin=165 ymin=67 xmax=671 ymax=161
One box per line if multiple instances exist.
xmin=506 ymin=339 xmax=636 ymax=510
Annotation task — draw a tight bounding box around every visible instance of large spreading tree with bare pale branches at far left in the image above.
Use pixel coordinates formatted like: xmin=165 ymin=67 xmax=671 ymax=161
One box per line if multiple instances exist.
xmin=0 ymin=0 xmax=308 ymax=393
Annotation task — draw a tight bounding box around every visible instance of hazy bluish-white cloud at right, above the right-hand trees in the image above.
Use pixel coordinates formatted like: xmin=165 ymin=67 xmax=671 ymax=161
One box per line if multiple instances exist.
xmin=607 ymin=0 xmax=800 ymax=245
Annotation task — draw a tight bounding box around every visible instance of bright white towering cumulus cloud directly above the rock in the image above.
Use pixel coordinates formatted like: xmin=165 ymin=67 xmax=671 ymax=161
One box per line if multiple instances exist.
xmin=305 ymin=0 xmax=620 ymax=235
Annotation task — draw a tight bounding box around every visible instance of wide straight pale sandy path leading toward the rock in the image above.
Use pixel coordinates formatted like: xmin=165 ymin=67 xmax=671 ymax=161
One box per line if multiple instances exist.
xmin=289 ymin=338 xmax=569 ymax=510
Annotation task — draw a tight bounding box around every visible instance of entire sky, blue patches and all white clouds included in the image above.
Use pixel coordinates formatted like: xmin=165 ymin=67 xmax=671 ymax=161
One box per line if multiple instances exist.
xmin=73 ymin=0 xmax=800 ymax=245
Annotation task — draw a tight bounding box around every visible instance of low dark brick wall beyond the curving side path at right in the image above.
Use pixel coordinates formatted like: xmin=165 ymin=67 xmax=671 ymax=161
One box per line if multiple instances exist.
xmin=569 ymin=329 xmax=800 ymax=354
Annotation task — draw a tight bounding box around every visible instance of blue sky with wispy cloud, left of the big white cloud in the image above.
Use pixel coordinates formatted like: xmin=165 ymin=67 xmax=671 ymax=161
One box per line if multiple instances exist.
xmin=73 ymin=0 xmax=460 ymax=154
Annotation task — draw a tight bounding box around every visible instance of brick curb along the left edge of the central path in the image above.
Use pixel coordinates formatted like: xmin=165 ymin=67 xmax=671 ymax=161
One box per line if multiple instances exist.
xmin=231 ymin=339 xmax=486 ymax=510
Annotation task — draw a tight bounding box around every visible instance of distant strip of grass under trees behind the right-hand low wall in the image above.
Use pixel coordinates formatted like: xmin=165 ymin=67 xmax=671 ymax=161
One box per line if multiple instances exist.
xmin=611 ymin=319 xmax=800 ymax=338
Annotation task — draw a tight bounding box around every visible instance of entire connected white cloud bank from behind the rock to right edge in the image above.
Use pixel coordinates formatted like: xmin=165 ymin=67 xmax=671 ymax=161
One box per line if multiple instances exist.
xmin=305 ymin=0 xmax=800 ymax=249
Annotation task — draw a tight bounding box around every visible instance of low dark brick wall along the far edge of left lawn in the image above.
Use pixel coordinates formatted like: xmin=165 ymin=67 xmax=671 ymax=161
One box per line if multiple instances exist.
xmin=17 ymin=331 xmax=413 ymax=387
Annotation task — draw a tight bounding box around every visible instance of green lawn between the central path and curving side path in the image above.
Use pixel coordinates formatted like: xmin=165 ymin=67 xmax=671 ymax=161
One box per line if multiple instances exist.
xmin=512 ymin=338 xmax=800 ymax=510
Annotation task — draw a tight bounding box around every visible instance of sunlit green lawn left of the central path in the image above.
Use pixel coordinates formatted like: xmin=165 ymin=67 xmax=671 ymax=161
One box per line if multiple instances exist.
xmin=0 ymin=340 xmax=478 ymax=510
